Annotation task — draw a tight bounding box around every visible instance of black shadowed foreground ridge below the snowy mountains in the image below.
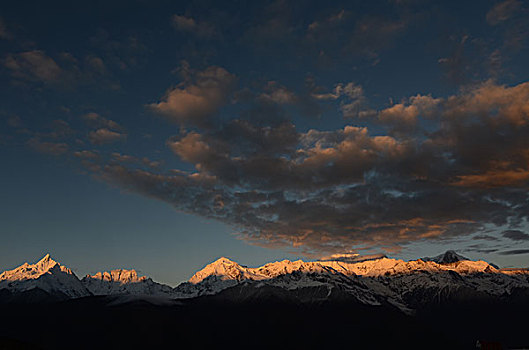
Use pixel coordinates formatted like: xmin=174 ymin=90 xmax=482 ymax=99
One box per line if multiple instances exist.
xmin=0 ymin=286 xmax=529 ymax=349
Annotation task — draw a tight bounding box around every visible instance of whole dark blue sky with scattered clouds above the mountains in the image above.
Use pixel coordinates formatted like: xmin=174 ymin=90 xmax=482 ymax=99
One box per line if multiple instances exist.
xmin=0 ymin=0 xmax=529 ymax=285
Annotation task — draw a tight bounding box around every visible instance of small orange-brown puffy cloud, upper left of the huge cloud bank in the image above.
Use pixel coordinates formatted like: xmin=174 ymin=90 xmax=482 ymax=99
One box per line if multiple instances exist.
xmin=149 ymin=65 xmax=236 ymax=126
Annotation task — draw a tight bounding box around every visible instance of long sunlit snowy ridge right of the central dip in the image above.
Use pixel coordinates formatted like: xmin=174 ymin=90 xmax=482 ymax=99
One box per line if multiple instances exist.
xmin=175 ymin=251 xmax=529 ymax=312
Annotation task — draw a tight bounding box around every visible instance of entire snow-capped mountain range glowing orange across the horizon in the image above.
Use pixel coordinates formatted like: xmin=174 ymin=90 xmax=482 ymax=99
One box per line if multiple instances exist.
xmin=0 ymin=251 xmax=529 ymax=314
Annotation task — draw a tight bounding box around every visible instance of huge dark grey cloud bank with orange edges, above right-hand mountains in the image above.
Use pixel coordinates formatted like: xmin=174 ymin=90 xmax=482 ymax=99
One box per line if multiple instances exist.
xmin=74 ymin=78 xmax=529 ymax=254
